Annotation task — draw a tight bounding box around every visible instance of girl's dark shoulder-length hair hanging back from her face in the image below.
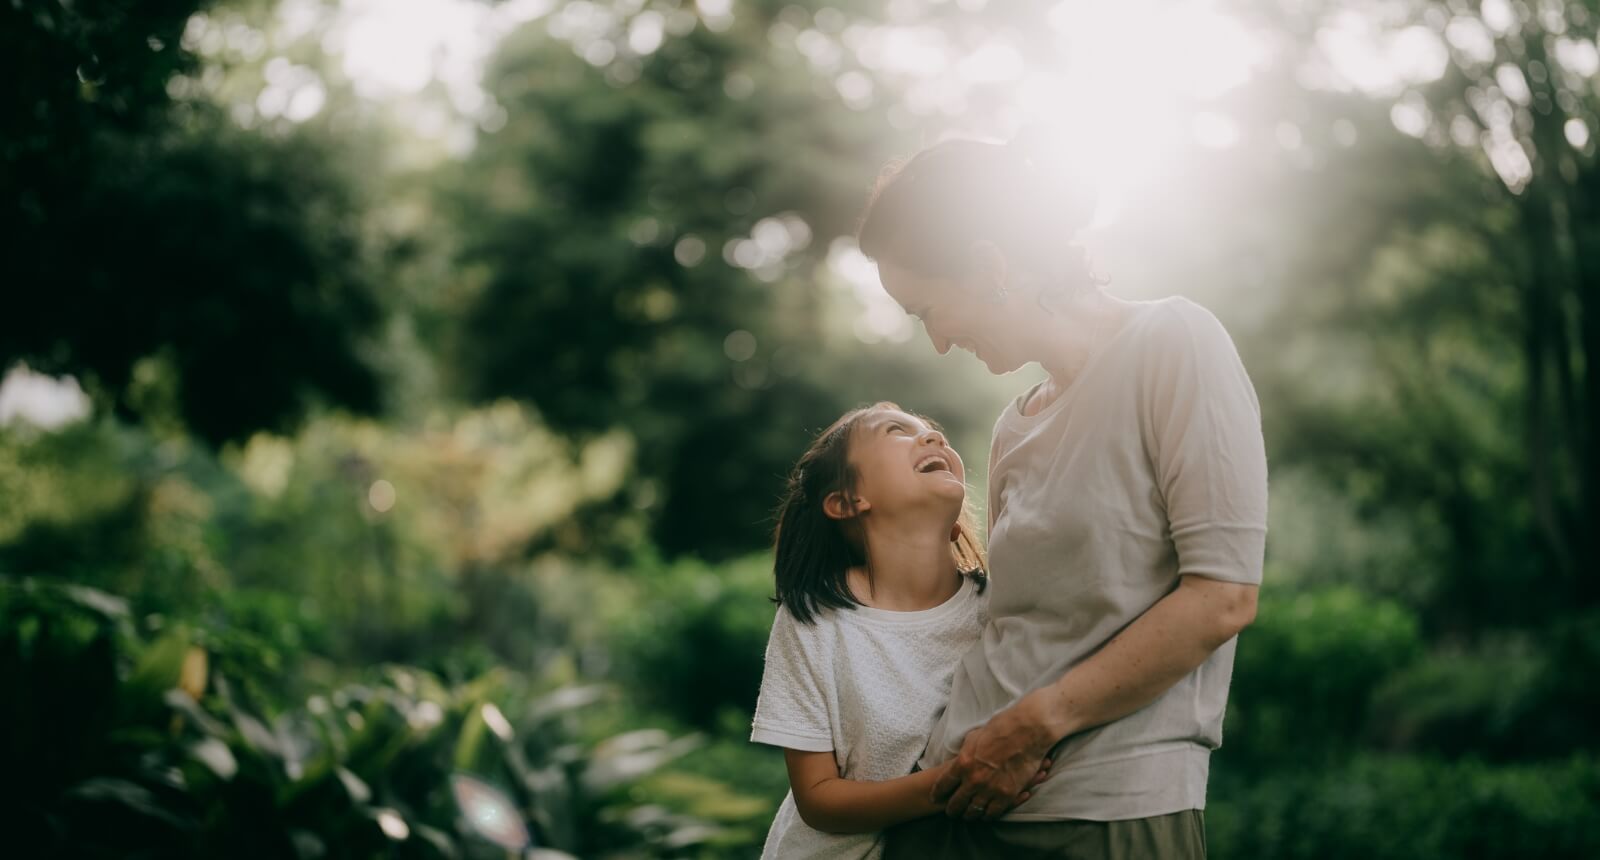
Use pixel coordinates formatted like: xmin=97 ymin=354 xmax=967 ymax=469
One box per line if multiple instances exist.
xmin=773 ymin=401 xmax=984 ymax=623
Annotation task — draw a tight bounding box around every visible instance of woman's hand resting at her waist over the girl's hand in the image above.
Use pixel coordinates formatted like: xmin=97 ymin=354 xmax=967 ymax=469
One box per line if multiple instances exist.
xmin=933 ymin=695 xmax=1056 ymax=822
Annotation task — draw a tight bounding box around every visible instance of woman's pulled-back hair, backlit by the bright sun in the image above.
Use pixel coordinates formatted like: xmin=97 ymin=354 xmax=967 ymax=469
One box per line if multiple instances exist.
xmin=856 ymin=139 xmax=1098 ymax=291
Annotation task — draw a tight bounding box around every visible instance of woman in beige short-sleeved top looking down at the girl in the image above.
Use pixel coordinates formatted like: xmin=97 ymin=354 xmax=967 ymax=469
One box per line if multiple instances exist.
xmin=859 ymin=141 xmax=1267 ymax=860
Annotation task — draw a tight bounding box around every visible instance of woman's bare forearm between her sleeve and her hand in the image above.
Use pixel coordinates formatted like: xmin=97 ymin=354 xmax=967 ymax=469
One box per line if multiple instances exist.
xmin=1019 ymin=575 xmax=1256 ymax=747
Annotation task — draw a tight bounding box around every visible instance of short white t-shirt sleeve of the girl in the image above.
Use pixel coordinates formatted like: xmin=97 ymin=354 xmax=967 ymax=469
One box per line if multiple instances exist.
xmin=750 ymin=607 xmax=834 ymax=753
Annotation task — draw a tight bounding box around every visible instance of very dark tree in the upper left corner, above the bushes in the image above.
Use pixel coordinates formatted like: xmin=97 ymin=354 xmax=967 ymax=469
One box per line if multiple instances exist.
xmin=0 ymin=2 xmax=381 ymax=443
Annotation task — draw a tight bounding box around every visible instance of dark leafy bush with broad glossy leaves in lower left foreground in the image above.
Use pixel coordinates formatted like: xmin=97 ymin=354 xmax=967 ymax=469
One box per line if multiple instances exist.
xmin=0 ymin=580 xmax=717 ymax=858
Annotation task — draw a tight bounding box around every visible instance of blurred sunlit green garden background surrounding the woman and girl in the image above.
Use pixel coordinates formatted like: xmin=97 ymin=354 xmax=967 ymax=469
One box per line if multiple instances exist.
xmin=0 ymin=0 xmax=1600 ymax=858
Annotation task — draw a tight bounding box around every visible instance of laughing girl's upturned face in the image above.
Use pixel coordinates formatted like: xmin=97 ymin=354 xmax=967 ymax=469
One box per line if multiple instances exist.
xmin=850 ymin=409 xmax=966 ymax=516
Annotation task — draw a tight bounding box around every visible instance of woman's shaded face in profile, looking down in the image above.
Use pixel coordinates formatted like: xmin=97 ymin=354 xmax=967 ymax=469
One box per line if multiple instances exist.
xmin=878 ymin=261 xmax=1029 ymax=374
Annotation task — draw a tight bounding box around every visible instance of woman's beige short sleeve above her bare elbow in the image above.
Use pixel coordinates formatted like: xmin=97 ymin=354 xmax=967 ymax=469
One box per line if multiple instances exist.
xmin=1141 ymin=305 xmax=1267 ymax=585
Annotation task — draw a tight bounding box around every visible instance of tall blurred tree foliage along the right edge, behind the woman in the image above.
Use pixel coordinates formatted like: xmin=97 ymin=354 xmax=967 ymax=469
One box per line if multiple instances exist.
xmin=1251 ymin=3 xmax=1600 ymax=623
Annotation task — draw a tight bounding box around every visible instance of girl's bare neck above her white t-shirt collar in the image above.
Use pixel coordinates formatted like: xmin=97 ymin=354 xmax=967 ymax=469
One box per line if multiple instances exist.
xmin=850 ymin=523 xmax=962 ymax=612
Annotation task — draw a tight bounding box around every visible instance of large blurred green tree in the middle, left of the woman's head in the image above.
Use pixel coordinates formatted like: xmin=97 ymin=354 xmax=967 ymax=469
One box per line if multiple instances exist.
xmin=451 ymin=8 xmax=921 ymax=556
